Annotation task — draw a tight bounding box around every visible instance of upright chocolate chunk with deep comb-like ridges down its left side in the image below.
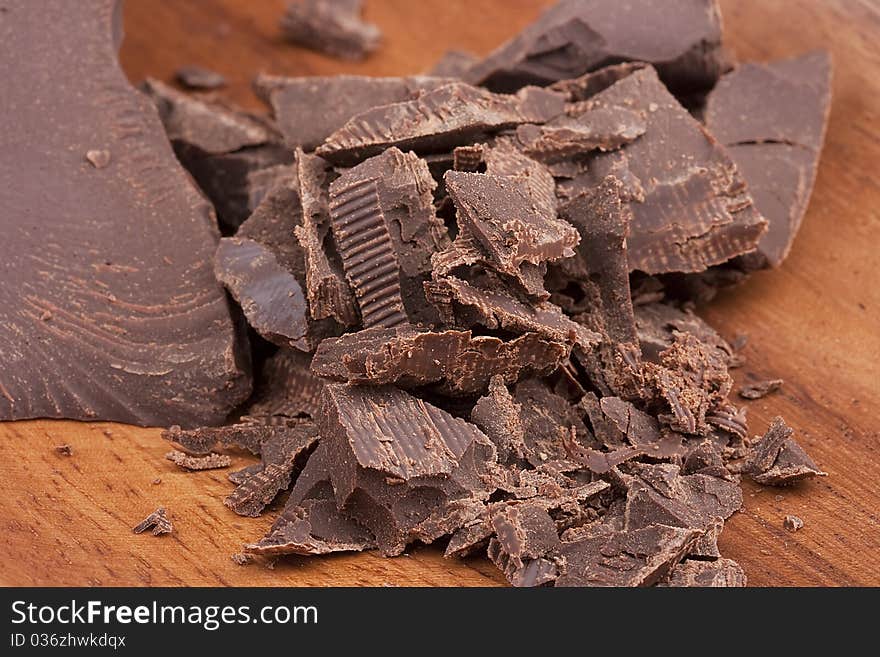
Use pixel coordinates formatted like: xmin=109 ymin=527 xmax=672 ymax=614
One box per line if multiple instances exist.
xmin=330 ymin=148 xmax=448 ymax=328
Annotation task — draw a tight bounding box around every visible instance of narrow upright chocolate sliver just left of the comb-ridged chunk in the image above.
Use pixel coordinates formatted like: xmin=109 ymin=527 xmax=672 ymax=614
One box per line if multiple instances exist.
xmin=294 ymin=150 xmax=359 ymax=326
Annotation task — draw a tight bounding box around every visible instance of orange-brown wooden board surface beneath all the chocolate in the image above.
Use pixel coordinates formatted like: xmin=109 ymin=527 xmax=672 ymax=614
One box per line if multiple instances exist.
xmin=0 ymin=0 xmax=880 ymax=585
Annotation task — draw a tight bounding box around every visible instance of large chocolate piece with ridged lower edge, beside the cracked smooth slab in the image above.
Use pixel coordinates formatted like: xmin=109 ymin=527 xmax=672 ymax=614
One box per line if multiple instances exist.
xmin=585 ymin=67 xmax=767 ymax=274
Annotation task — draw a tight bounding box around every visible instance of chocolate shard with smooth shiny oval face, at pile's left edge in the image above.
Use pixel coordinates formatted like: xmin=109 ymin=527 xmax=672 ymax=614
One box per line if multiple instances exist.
xmin=214 ymin=171 xmax=336 ymax=351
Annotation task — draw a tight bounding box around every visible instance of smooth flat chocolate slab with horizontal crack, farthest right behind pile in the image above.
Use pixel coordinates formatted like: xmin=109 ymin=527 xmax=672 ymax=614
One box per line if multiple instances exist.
xmin=704 ymin=51 xmax=831 ymax=268
